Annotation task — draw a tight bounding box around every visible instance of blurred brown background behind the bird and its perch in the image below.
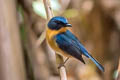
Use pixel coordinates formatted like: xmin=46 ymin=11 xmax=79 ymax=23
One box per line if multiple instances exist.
xmin=0 ymin=0 xmax=120 ymax=80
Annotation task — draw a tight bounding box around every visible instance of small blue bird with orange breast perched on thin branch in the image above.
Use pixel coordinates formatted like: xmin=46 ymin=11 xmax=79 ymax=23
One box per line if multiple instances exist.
xmin=46 ymin=16 xmax=104 ymax=72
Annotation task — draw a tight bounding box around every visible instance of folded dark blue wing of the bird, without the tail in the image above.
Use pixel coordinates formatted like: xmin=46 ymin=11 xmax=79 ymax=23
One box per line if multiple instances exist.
xmin=55 ymin=33 xmax=85 ymax=64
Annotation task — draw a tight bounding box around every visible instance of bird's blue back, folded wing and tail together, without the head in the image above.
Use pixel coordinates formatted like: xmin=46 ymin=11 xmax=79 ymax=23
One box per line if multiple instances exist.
xmin=55 ymin=30 xmax=104 ymax=71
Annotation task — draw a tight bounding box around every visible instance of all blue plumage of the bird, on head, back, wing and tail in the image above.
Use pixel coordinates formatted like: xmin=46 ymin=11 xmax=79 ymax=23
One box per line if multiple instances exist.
xmin=48 ymin=16 xmax=104 ymax=71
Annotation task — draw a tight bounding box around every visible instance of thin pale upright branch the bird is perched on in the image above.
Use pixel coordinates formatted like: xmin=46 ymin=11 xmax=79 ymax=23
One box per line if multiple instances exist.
xmin=43 ymin=0 xmax=67 ymax=80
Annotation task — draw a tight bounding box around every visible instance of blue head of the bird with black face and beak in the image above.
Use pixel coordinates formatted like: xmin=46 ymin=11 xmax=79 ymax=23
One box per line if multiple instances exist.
xmin=48 ymin=16 xmax=72 ymax=30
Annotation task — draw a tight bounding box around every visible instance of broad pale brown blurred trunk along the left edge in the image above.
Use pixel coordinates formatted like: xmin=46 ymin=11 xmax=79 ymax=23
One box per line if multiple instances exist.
xmin=0 ymin=0 xmax=26 ymax=80
